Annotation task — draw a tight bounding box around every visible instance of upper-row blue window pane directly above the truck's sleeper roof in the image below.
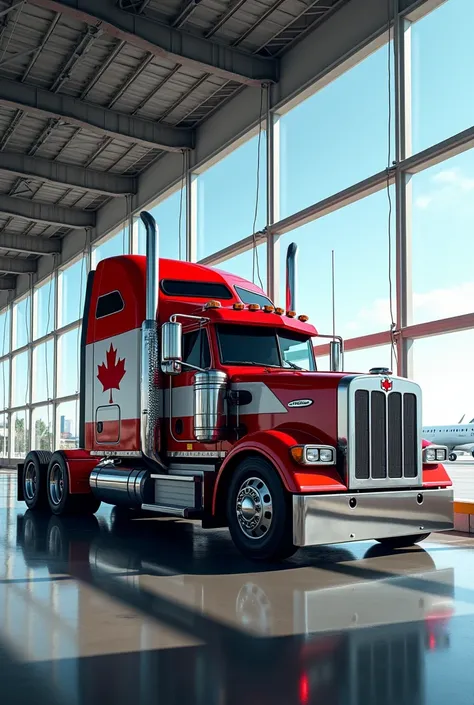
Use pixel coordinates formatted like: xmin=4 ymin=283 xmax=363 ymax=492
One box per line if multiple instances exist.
xmin=197 ymin=132 xmax=266 ymax=259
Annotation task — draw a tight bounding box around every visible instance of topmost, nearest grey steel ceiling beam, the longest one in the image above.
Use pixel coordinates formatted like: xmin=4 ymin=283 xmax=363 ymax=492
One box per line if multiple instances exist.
xmin=31 ymin=0 xmax=278 ymax=86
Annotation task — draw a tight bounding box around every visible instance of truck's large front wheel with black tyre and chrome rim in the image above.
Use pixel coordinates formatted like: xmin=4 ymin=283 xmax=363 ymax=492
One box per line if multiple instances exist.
xmin=227 ymin=457 xmax=298 ymax=561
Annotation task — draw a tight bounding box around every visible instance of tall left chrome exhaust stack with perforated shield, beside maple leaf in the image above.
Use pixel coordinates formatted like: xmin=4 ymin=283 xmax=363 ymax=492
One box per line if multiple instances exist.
xmin=140 ymin=211 xmax=165 ymax=467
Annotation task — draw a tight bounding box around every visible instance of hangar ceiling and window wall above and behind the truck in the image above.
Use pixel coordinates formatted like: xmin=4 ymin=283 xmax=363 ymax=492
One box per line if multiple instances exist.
xmin=0 ymin=0 xmax=474 ymax=465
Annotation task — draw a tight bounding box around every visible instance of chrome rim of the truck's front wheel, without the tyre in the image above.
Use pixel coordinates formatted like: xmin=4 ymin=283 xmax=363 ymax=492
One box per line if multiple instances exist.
xmin=235 ymin=477 xmax=273 ymax=540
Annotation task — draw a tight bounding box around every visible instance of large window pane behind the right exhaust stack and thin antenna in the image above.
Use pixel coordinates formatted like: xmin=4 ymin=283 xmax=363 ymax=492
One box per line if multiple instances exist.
xmin=280 ymin=189 xmax=396 ymax=338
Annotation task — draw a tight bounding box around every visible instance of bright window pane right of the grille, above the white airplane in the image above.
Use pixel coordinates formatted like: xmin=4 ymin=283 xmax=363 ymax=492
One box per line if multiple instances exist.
xmin=413 ymin=330 xmax=474 ymax=426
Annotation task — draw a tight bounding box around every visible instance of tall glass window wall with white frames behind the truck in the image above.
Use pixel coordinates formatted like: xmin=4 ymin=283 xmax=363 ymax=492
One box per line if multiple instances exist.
xmin=0 ymin=0 xmax=474 ymax=459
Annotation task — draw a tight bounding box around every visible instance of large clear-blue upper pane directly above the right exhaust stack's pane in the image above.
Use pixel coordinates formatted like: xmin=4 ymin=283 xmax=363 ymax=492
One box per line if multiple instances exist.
xmin=280 ymin=45 xmax=394 ymax=218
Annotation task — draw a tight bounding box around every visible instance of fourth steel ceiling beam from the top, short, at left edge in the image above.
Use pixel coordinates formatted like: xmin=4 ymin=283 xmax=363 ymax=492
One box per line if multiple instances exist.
xmin=0 ymin=193 xmax=95 ymax=229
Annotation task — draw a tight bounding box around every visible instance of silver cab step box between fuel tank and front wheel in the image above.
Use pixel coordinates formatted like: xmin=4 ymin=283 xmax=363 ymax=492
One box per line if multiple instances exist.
xmin=142 ymin=474 xmax=203 ymax=519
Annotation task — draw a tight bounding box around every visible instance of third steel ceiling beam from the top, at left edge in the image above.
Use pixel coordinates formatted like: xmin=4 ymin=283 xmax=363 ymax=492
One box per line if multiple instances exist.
xmin=0 ymin=152 xmax=137 ymax=196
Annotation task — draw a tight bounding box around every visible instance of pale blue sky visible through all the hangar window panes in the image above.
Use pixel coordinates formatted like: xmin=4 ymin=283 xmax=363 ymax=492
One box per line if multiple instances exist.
xmin=0 ymin=0 xmax=474 ymax=424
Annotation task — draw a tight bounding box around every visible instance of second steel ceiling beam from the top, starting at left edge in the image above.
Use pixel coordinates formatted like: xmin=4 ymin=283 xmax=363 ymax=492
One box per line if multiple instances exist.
xmin=0 ymin=78 xmax=194 ymax=151
